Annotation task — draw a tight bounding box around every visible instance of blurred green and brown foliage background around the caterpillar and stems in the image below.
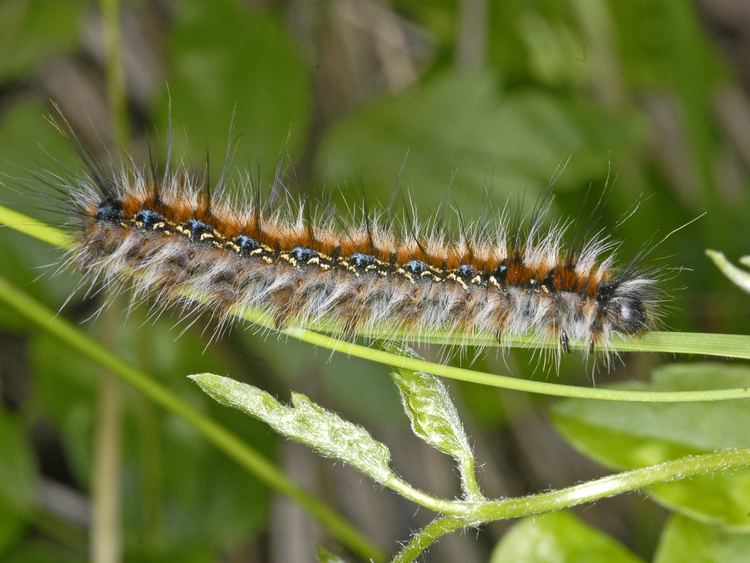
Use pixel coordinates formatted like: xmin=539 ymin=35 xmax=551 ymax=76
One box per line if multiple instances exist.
xmin=0 ymin=0 xmax=750 ymax=562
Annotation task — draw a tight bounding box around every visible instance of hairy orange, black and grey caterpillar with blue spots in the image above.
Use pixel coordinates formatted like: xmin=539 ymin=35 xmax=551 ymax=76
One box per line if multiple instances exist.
xmin=48 ymin=132 xmax=660 ymax=364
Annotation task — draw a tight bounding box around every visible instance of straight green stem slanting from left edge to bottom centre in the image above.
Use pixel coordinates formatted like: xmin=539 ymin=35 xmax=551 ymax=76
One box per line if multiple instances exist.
xmin=0 ymin=276 xmax=384 ymax=561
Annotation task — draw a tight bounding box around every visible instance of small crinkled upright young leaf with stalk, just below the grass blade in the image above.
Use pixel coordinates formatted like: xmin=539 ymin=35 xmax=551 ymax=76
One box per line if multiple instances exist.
xmin=389 ymin=346 xmax=482 ymax=499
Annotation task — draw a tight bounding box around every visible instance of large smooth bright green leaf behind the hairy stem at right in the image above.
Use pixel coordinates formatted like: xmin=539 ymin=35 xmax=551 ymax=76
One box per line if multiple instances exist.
xmin=553 ymin=363 xmax=750 ymax=530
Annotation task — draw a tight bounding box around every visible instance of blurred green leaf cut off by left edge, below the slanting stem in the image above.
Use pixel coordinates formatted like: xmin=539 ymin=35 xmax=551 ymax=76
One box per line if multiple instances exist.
xmin=0 ymin=408 xmax=37 ymax=551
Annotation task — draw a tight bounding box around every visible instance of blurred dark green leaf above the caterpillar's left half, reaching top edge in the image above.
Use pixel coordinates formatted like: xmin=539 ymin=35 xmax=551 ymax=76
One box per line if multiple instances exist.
xmin=154 ymin=0 xmax=312 ymax=178
